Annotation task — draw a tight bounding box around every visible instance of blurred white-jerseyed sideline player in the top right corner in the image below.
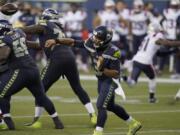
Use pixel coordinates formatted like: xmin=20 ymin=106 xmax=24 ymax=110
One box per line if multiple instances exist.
xmin=159 ymin=0 xmax=180 ymax=75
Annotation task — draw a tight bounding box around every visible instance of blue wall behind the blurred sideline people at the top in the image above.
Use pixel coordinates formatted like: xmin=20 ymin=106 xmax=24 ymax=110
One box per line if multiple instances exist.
xmin=11 ymin=0 xmax=169 ymax=30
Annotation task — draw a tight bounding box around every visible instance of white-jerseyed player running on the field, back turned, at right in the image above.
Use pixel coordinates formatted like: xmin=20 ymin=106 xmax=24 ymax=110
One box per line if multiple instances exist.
xmin=127 ymin=23 xmax=179 ymax=103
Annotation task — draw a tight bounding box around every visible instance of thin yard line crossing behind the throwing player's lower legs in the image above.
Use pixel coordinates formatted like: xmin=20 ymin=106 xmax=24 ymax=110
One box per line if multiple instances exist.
xmin=13 ymin=110 xmax=180 ymax=119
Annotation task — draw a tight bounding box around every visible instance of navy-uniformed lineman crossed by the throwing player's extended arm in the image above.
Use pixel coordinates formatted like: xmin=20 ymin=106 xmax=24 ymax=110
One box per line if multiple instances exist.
xmin=23 ymin=9 xmax=97 ymax=124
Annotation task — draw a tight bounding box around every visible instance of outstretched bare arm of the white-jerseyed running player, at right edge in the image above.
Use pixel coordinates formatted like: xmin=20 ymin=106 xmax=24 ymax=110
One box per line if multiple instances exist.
xmin=156 ymin=39 xmax=180 ymax=47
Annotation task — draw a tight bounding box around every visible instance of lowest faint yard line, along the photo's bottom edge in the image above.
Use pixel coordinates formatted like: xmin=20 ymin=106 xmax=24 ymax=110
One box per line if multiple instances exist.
xmin=80 ymin=129 xmax=180 ymax=135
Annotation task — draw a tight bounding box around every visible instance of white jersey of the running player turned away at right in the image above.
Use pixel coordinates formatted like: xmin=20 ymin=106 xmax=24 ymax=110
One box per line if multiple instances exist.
xmin=133 ymin=32 xmax=164 ymax=65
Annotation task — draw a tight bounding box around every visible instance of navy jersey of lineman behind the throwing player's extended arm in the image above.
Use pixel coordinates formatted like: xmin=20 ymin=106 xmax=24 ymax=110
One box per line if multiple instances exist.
xmin=39 ymin=20 xmax=71 ymax=58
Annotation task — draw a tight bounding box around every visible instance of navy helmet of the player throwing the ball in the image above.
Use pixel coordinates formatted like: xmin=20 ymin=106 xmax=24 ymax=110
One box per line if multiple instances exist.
xmin=93 ymin=26 xmax=113 ymax=48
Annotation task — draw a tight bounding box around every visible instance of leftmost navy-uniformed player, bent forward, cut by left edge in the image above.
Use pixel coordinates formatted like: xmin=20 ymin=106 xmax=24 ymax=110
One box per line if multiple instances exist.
xmin=0 ymin=20 xmax=64 ymax=130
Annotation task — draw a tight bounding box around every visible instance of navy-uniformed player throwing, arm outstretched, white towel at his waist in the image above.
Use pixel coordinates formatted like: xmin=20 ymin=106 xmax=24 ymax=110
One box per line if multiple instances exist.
xmin=46 ymin=26 xmax=141 ymax=135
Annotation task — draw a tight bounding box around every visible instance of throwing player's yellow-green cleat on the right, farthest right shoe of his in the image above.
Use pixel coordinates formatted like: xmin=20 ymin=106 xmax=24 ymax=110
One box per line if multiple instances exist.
xmin=127 ymin=119 xmax=142 ymax=135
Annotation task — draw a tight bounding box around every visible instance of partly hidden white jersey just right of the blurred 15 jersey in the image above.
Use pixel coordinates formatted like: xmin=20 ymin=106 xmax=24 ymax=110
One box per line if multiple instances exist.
xmin=119 ymin=9 xmax=130 ymax=35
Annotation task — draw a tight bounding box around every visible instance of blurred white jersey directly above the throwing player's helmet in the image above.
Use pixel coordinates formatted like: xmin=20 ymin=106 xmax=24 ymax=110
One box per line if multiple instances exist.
xmin=98 ymin=10 xmax=119 ymax=41
